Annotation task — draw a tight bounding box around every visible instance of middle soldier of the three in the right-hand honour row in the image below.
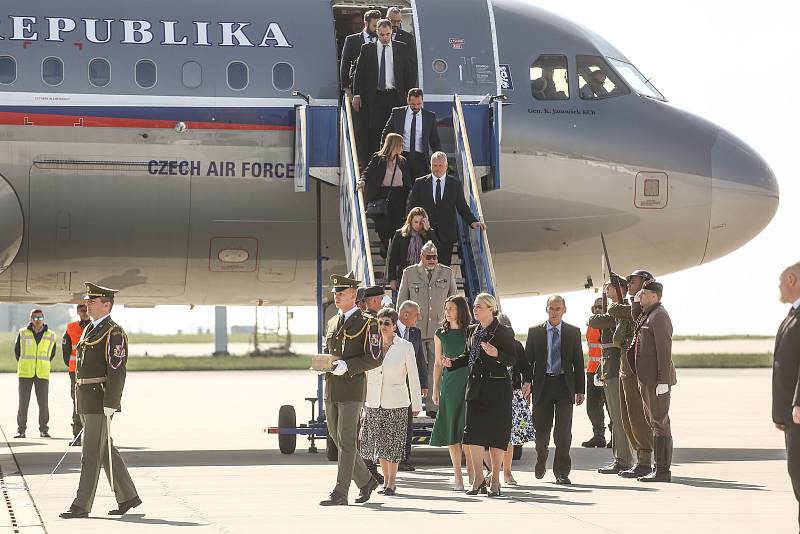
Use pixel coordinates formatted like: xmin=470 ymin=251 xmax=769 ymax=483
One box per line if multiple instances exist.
xmin=608 ymin=270 xmax=653 ymax=478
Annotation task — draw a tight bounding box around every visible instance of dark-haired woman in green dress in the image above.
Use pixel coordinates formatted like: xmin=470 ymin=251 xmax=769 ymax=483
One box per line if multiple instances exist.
xmin=430 ymin=295 xmax=473 ymax=491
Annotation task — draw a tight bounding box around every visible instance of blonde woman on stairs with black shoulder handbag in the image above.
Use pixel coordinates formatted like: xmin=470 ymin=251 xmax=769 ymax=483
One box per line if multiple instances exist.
xmin=358 ymin=134 xmax=412 ymax=253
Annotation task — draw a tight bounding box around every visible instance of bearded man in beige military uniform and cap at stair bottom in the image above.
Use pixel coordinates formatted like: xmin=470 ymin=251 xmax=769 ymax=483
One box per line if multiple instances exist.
xmin=397 ymin=241 xmax=458 ymax=415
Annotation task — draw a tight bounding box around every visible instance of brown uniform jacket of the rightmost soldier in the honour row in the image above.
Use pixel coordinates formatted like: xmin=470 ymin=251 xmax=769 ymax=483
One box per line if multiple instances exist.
xmin=636 ymin=303 xmax=678 ymax=386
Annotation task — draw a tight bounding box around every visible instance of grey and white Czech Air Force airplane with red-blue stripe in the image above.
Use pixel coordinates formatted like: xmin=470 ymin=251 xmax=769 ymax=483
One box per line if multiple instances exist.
xmin=0 ymin=0 xmax=779 ymax=307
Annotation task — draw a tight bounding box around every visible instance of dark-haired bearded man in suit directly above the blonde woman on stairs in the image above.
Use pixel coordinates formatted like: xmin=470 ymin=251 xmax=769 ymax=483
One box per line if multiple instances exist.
xmin=381 ymin=87 xmax=442 ymax=178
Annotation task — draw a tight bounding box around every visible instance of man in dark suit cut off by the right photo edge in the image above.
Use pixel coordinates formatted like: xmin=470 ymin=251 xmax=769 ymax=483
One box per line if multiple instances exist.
xmin=772 ymin=262 xmax=800 ymax=523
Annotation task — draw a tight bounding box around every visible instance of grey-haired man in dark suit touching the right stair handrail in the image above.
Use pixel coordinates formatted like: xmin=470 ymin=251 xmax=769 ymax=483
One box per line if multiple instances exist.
xmin=406 ymin=152 xmax=486 ymax=267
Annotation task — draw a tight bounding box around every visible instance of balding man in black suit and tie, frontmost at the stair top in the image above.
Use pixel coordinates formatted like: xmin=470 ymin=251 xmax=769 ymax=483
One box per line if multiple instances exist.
xmin=353 ymin=19 xmax=417 ymax=159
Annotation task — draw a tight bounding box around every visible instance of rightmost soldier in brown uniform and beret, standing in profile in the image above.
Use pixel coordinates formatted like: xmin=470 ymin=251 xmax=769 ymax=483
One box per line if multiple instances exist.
xmin=634 ymin=280 xmax=677 ymax=482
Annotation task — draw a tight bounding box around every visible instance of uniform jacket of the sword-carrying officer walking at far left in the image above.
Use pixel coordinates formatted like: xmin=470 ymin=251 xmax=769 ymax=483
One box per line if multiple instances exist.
xmin=75 ymin=317 xmax=128 ymax=415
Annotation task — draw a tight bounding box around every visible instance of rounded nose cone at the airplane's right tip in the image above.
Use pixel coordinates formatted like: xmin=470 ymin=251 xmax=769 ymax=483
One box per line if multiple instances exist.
xmin=703 ymin=129 xmax=780 ymax=263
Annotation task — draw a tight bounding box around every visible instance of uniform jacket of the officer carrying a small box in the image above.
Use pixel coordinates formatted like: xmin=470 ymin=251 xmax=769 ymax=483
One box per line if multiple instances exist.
xmin=325 ymin=310 xmax=383 ymax=402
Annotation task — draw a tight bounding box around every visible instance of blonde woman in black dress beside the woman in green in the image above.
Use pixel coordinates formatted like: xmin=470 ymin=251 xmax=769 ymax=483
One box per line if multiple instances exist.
xmin=444 ymin=293 xmax=517 ymax=497
